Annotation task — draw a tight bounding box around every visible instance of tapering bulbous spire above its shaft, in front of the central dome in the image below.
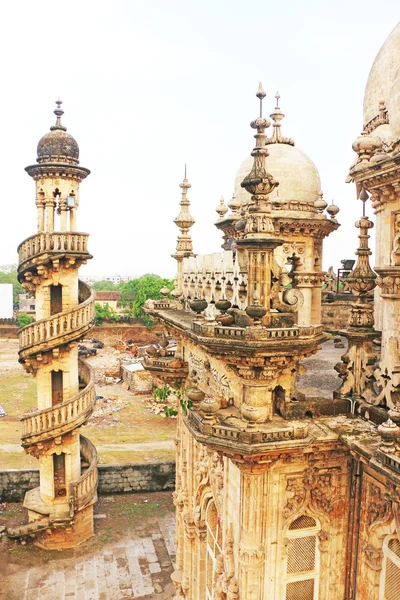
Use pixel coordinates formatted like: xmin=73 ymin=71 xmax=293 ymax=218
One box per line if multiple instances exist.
xmin=241 ymin=83 xmax=279 ymax=237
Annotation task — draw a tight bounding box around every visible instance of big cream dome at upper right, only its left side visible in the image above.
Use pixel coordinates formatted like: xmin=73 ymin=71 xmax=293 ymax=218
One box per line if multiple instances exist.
xmin=364 ymin=23 xmax=400 ymax=125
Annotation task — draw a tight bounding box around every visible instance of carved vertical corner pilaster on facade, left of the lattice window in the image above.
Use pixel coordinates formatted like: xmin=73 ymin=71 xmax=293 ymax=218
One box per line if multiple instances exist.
xmin=238 ymin=464 xmax=266 ymax=600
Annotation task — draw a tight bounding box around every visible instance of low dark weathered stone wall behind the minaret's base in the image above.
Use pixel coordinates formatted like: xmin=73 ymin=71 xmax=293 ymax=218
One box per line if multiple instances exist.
xmin=0 ymin=461 xmax=175 ymax=502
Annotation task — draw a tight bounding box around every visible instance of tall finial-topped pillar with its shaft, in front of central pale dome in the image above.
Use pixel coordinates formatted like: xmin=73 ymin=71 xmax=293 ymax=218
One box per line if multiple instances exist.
xmin=237 ymin=83 xmax=283 ymax=325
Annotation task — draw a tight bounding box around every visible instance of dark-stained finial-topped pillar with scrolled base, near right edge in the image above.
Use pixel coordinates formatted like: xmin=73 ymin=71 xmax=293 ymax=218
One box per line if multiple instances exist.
xmin=335 ymin=200 xmax=379 ymax=403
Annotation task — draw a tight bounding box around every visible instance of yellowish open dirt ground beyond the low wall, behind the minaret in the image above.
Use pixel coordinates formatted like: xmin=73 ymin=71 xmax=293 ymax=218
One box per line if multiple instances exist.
xmin=0 ymin=338 xmax=176 ymax=469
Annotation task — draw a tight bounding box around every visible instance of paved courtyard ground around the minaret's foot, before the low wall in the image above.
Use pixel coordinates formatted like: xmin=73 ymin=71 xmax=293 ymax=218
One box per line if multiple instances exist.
xmin=0 ymin=492 xmax=175 ymax=600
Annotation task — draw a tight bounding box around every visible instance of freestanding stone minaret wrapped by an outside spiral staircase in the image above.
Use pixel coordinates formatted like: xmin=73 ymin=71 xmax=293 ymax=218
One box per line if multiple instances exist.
xmin=8 ymin=101 xmax=97 ymax=549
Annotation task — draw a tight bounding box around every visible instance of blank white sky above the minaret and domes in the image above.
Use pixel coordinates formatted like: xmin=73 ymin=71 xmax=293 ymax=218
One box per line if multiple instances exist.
xmin=0 ymin=0 xmax=400 ymax=276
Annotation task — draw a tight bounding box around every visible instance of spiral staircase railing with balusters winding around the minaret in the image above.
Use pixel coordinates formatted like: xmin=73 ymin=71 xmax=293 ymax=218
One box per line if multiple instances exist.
xmin=7 ymin=232 xmax=98 ymax=537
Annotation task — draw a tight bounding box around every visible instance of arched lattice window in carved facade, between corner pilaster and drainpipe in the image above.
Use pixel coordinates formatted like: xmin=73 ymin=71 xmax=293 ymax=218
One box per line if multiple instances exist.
xmin=284 ymin=515 xmax=320 ymax=600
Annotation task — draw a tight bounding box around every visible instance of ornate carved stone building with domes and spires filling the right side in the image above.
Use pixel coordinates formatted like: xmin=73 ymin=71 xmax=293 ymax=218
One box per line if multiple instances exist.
xmin=147 ymin=25 xmax=400 ymax=600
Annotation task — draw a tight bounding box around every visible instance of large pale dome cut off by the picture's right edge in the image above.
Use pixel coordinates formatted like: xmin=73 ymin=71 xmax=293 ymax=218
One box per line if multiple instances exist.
xmin=364 ymin=23 xmax=400 ymax=134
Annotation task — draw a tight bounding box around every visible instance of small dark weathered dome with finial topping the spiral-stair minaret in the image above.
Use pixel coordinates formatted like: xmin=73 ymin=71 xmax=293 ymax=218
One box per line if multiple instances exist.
xmin=37 ymin=100 xmax=79 ymax=165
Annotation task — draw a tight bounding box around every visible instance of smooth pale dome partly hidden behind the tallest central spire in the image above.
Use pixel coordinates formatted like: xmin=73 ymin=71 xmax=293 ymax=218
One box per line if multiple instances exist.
xmin=235 ymin=144 xmax=321 ymax=204
